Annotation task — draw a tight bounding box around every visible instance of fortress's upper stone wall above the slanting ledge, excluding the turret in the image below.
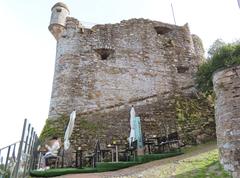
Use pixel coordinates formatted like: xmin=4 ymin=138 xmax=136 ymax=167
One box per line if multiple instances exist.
xmin=49 ymin=18 xmax=202 ymax=118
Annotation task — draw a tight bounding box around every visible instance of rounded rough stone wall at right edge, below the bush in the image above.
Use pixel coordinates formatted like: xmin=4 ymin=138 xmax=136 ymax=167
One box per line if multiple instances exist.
xmin=213 ymin=66 xmax=240 ymax=178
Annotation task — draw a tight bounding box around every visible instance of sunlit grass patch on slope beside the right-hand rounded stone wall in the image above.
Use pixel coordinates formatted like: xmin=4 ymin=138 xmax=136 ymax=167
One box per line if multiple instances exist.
xmin=139 ymin=148 xmax=231 ymax=178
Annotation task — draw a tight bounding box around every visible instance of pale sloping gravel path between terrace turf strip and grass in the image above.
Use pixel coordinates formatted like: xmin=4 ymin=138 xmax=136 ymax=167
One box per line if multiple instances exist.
xmin=55 ymin=144 xmax=217 ymax=178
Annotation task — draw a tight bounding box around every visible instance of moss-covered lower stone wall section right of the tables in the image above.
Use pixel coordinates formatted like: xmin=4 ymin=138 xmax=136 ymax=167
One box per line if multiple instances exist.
xmin=175 ymin=93 xmax=215 ymax=144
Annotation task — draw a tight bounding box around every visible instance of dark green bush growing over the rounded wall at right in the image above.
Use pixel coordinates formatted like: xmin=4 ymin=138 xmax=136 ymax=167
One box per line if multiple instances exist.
xmin=196 ymin=43 xmax=240 ymax=93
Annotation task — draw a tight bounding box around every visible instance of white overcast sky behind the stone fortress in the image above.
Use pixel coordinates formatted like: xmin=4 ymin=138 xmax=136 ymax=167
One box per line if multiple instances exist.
xmin=0 ymin=0 xmax=240 ymax=148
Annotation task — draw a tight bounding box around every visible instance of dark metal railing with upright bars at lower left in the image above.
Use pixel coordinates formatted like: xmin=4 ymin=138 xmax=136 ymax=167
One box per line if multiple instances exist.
xmin=0 ymin=119 xmax=39 ymax=178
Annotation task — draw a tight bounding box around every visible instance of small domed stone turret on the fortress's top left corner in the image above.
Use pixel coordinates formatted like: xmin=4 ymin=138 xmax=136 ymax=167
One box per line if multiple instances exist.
xmin=48 ymin=2 xmax=69 ymax=40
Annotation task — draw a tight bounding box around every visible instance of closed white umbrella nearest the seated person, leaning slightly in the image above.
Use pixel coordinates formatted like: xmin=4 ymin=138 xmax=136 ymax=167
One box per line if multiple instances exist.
xmin=64 ymin=111 xmax=76 ymax=150
